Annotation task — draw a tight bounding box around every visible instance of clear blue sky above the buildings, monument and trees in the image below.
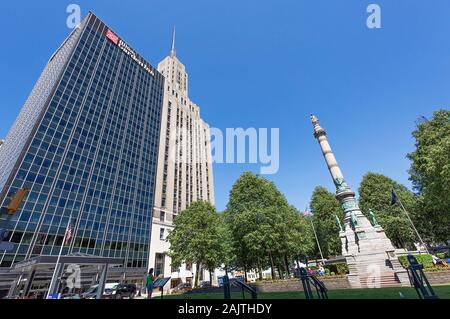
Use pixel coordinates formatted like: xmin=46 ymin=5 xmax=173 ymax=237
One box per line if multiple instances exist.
xmin=0 ymin=0 xmax=450 ymax=209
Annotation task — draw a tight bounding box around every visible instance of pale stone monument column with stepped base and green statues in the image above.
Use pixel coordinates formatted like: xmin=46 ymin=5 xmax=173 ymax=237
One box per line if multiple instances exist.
xmin=311 ymin=115 xmax=409 ymax=288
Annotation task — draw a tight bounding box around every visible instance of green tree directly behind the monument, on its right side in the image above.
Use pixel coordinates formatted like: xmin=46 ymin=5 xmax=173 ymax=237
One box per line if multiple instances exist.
xmin=359 ymin=173 xmax=421 ymax=248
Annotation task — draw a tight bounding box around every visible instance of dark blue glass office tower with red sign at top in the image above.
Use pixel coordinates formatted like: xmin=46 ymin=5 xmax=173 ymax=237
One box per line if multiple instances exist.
xmin=0 ymin=13 xmax=164 ymax=269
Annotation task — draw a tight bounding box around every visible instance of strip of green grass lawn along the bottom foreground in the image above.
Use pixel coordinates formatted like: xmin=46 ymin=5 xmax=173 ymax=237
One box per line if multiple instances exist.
xmin=164 ymin=286 xmax=450 ymax=299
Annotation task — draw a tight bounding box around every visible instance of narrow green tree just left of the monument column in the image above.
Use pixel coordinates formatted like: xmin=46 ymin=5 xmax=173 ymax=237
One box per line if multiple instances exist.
xmin=310 ymin=186 xmax=344 ymax=258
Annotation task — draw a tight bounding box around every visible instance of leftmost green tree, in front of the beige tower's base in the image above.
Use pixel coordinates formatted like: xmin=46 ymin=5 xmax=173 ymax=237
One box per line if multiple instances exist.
xmin=167 ymin=201 xmax=226 ymax=287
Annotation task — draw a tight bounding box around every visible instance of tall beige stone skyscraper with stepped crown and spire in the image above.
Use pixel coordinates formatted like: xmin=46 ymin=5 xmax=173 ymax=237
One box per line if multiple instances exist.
xmin=150 ymin=30 xmax=214 ymax=285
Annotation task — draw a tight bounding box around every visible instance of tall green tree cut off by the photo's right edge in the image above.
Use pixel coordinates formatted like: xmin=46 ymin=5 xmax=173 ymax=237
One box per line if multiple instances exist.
xmin=408 ymin=110 xmax=450 ymax=242
